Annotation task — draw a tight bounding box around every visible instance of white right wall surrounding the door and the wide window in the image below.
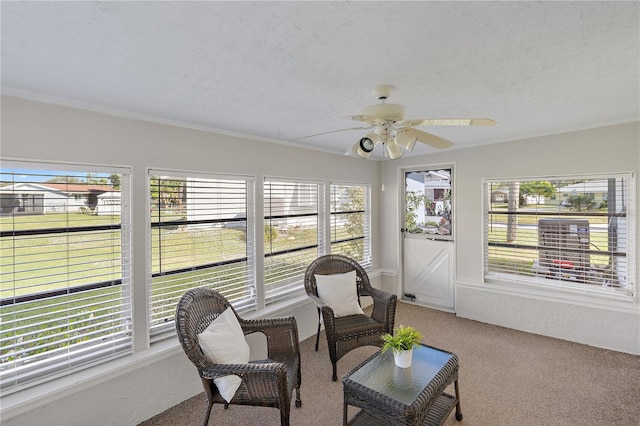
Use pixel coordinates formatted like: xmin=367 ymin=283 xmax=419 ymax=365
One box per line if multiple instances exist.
xmin=380 ymin=122 xmax=640 ymax=354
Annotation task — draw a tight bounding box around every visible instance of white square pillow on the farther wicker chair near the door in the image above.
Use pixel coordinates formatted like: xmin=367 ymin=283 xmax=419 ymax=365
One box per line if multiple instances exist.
xmin=314 ymin=271 xmax=364 ymax=318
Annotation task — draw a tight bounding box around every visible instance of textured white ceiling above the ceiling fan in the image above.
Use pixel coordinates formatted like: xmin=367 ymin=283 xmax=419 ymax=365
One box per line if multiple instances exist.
xmin=0 ymin=1 xmax=640 ymax=159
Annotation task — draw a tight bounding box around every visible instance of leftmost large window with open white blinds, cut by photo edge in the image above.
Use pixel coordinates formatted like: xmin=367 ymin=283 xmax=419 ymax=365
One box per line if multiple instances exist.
xmin=0 ymin=161 xmax=133 ymax=394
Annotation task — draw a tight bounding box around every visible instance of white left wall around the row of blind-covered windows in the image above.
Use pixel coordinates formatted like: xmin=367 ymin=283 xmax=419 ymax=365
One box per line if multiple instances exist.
xmin=0 ymin=96 xmax=379 ymax=426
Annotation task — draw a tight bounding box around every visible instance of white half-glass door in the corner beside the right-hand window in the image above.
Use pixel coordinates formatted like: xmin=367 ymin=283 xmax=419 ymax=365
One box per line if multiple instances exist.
xmin=402 ymin=166 xmax=455 ymax=312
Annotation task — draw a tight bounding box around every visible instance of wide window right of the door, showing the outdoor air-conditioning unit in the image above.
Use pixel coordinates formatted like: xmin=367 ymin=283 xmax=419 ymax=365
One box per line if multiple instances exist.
xmin=484 ymin=173 xmax=635 ymax=300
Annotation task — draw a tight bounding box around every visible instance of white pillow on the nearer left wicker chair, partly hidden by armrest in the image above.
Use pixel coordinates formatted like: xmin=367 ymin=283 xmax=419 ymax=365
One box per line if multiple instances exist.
xmin=198 ymin=308 xmax=249 ymax=402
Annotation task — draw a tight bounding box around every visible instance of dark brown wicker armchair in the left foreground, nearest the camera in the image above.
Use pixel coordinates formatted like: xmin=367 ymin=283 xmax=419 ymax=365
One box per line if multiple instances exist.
xmin=176 ymin=288 xmax=302 ymax=426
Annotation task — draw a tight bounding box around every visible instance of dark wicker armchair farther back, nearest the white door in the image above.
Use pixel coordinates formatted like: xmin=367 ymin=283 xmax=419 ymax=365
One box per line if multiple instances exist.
xmin=304 ymin=254 xmax=397 ymax=382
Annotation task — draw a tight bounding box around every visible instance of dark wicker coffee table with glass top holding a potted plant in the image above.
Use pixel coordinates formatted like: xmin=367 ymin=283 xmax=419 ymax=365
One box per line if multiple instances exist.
xmin=342 ymin=345 xmax=462 ymax=426
